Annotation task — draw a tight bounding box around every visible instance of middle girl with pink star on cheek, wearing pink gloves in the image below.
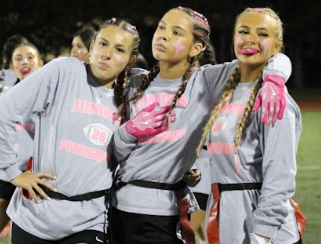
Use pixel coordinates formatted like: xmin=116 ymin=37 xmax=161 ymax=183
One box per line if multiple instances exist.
xmin=111 ymin=7 xmax=291 ymax=244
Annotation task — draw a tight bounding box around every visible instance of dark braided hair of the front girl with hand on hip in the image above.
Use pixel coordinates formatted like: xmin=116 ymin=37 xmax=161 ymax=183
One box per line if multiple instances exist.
xmin=94 ymin=18 xmax=140 ymax=112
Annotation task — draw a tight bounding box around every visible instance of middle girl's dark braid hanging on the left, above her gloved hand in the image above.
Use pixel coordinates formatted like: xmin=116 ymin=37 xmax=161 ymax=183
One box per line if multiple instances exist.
xmin=117 ymin=64 xmax=159 ymax=119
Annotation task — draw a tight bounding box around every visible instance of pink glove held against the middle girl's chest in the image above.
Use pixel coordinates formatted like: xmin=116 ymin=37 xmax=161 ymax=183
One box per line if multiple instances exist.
xmin=125 ymin=103 xmax=175 ymax=138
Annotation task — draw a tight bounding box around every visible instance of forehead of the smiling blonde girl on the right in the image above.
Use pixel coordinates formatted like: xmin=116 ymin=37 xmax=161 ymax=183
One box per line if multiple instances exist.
xmin=236 ymin=12 xmax=276 ymax=30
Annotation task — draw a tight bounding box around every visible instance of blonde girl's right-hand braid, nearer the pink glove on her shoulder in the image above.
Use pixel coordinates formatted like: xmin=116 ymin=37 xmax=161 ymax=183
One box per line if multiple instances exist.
xmin=234 ymin=70 xmax=263 ymax=148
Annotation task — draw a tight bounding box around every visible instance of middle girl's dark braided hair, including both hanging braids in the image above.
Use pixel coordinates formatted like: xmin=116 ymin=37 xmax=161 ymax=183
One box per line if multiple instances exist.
xmin=118 ymin=6 xmax=210 ymax=119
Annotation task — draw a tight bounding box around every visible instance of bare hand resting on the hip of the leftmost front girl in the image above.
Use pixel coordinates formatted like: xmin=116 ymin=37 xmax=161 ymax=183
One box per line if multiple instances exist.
xmin=11 ymin=171 xmax=57 ymax=203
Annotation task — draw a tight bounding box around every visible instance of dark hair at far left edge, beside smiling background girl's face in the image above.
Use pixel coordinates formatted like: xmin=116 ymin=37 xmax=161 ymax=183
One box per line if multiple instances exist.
xmin=2 ymin=35 xmax=28 ymax=69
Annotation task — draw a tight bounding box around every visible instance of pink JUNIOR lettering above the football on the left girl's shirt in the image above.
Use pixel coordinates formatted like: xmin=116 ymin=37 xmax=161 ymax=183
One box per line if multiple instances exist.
xmin=71 ymin=100 xmax=120 ymax=126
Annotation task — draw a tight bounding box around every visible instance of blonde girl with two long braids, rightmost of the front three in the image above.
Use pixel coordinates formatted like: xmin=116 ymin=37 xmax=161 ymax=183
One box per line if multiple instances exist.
xmin=198 ymin=8 xmax=304 ymax=244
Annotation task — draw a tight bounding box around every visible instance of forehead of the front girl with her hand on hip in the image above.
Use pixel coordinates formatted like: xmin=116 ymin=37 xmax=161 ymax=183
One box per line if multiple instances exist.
xmin=96 ymin=26 xmax=133 ymax=48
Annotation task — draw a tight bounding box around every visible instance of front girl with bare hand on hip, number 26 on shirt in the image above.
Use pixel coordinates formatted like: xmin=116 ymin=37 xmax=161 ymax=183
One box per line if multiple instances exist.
xmin=0 ymin=18 xmax=140 ymax=244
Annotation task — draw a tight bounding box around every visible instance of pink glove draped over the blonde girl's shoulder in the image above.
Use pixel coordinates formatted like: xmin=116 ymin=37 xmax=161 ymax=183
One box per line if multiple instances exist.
xmin=253 ymin=74 xmax=286 ymax=124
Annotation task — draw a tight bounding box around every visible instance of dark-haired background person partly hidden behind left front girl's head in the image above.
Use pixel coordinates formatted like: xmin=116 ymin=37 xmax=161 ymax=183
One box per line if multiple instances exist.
xmin=70 ymin=28 xmax=95 ymax=63
